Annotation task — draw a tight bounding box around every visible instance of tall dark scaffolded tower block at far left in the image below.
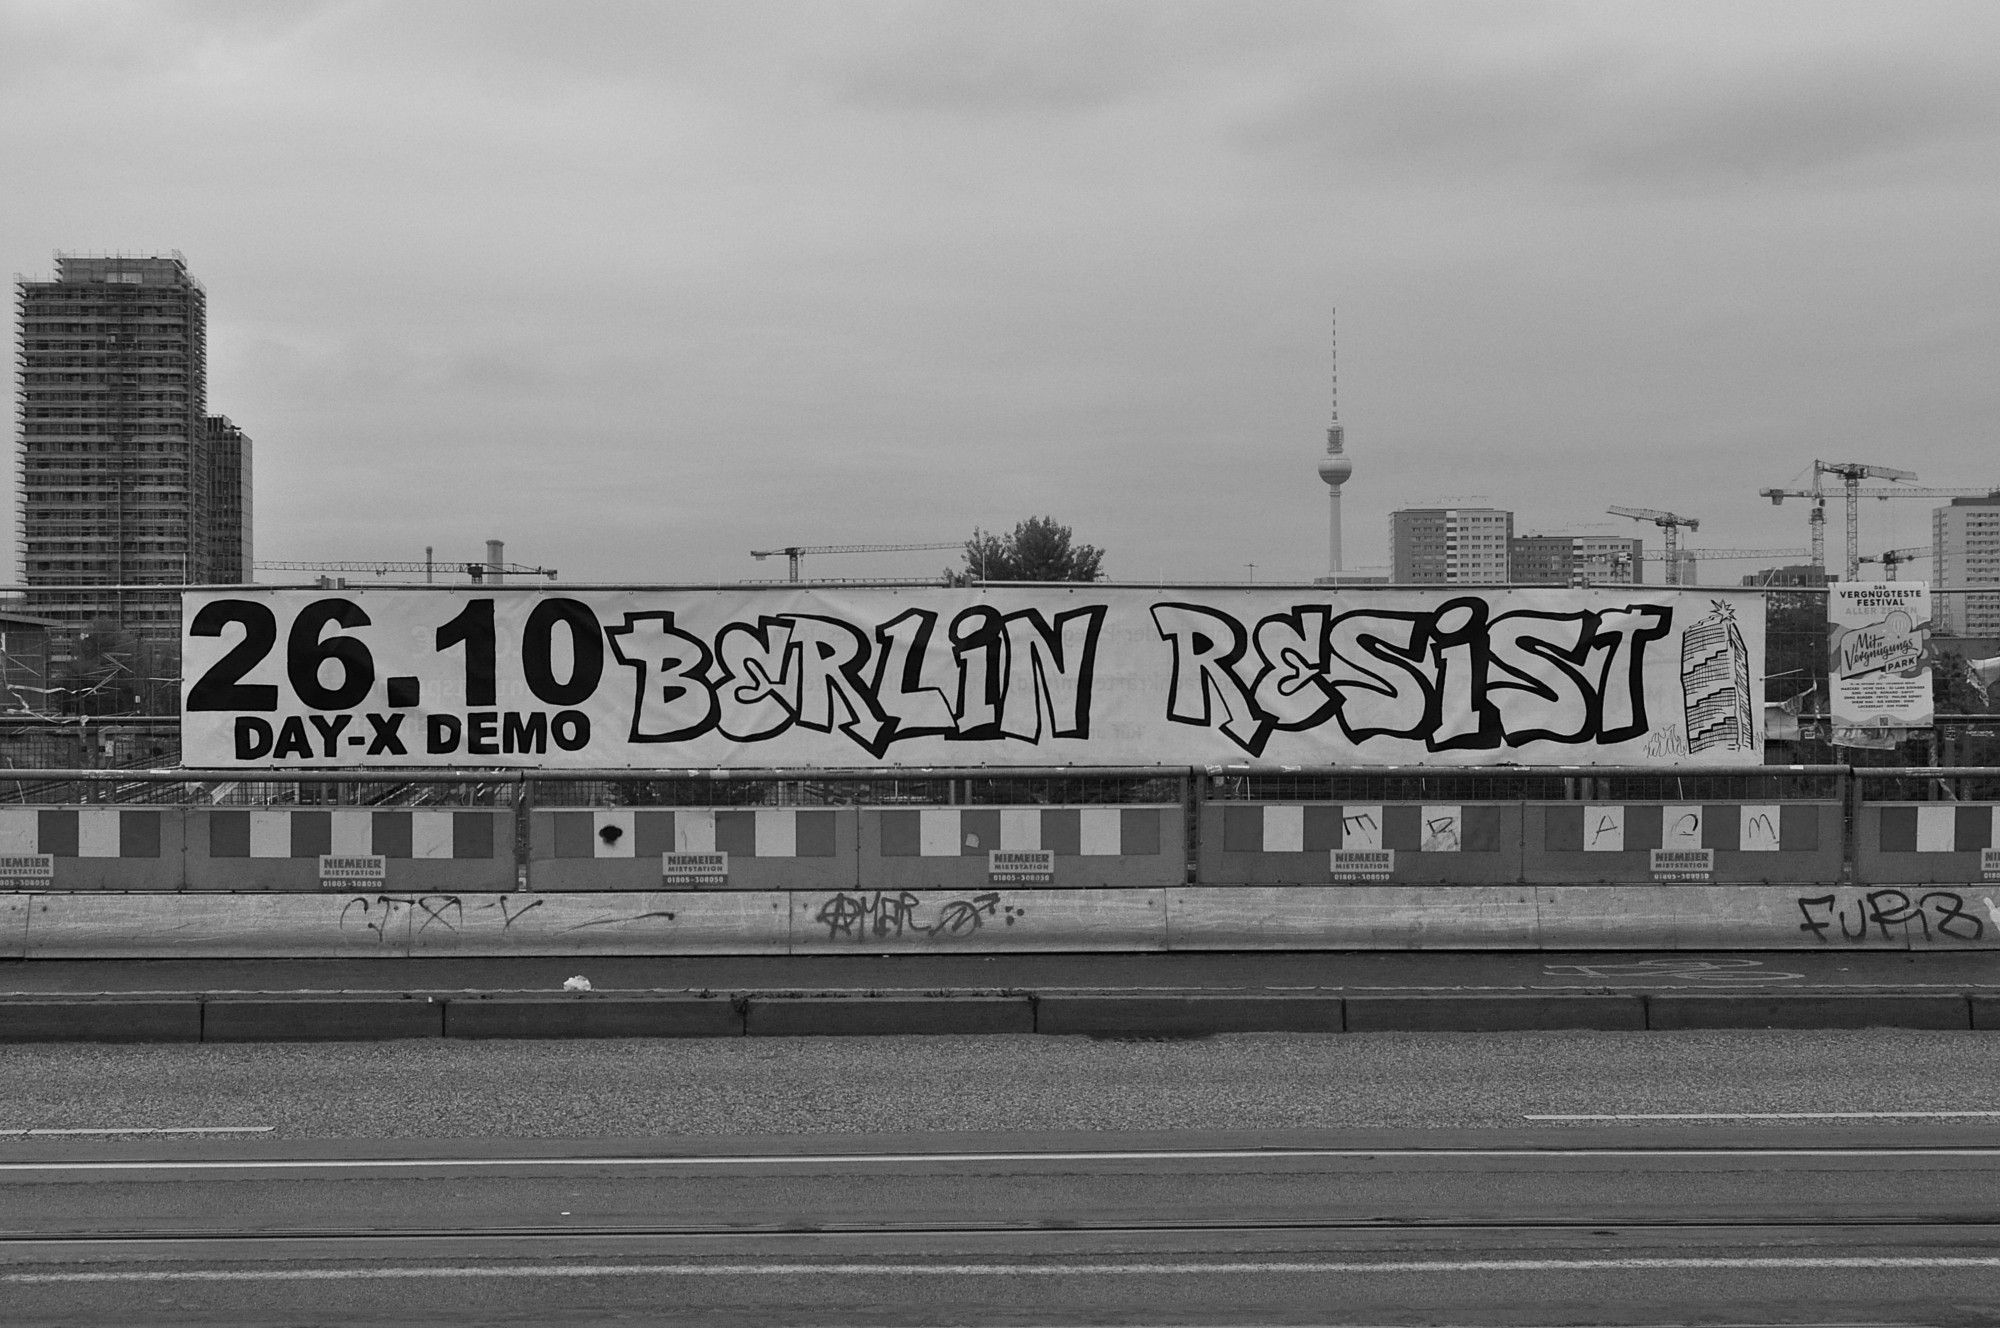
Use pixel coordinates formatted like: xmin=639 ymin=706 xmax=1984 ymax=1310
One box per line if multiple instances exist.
xmin=16 ymin=254 xmax=250 ymax=640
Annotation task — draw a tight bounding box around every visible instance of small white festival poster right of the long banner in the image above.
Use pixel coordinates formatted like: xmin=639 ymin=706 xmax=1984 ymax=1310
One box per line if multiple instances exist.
xmin=1826 ymin=582 xmax=1932 ymax=746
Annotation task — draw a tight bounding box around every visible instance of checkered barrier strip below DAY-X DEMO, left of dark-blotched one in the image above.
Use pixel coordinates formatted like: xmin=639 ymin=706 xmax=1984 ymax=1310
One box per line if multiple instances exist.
xmin=208 ymin=808 xmax=514 ymax=860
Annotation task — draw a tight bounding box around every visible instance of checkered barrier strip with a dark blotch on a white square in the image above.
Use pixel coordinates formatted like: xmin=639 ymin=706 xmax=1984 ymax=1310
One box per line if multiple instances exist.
xmin=542 ymin=808 xmax=838 ymax=866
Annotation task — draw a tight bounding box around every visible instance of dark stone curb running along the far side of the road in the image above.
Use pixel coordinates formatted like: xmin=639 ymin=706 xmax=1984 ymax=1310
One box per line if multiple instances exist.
xmin=0 ymin=992 xmax=2000 ymax=1044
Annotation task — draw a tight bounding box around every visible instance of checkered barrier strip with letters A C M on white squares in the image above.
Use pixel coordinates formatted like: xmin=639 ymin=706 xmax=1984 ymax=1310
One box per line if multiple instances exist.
xmin=1542 ymin=802 xmax=1822 ymax=854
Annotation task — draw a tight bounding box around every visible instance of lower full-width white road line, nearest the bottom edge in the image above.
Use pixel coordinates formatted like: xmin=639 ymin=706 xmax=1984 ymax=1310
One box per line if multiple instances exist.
xmin=11 ymin=1254 xmax=2000 ymax=1286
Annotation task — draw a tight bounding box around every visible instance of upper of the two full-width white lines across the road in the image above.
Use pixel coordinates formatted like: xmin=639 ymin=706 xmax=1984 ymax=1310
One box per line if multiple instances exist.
xmin=0 ymin=1146 xmax=2000 ymax=1174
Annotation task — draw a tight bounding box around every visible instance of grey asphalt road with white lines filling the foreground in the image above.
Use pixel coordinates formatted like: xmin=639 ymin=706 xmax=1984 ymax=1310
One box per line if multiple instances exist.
xmin=0 ymin=1032 xmax=2000 ymax=1324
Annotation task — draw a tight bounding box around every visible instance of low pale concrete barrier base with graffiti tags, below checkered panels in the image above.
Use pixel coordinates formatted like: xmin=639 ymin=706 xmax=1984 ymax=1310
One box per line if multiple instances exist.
xmin=11 ymin=886 xmax=2000 ymax=958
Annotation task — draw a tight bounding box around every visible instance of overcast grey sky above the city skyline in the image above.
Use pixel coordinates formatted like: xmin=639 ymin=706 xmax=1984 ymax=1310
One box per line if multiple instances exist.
xmin=0 ymin=0 xmax=2000 ymax=582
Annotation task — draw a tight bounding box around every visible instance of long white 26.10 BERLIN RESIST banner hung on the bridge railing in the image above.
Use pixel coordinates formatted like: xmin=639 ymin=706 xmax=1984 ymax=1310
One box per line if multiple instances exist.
xmin=182 ymin=584 xmax=1764 ymax=770
